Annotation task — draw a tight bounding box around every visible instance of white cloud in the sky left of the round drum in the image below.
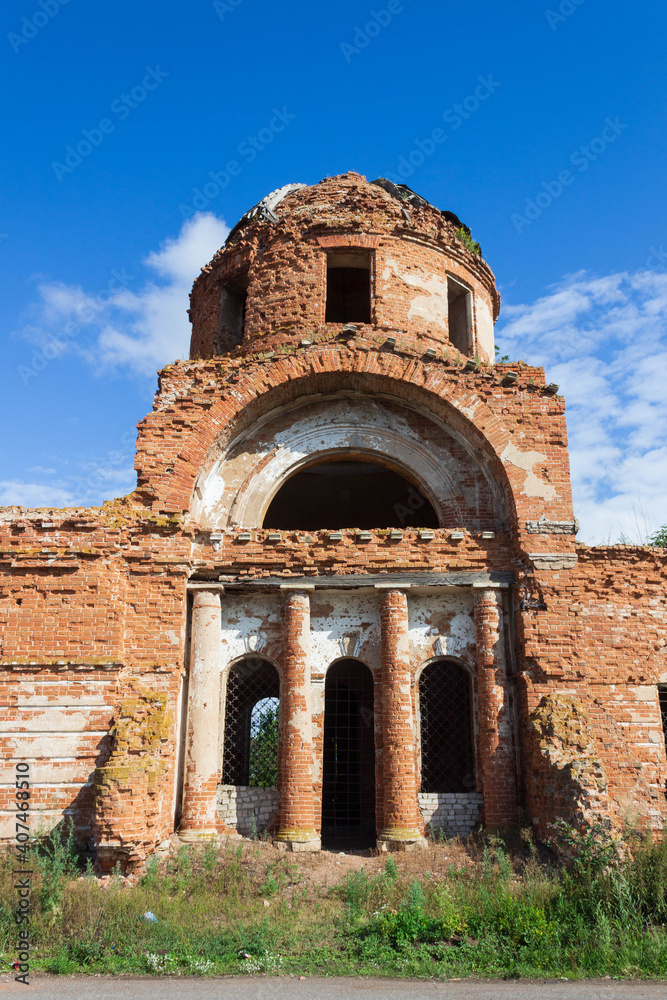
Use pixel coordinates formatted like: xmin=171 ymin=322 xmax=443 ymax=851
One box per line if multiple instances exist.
xmin=18 ymin=213 xmax=229 ymax=378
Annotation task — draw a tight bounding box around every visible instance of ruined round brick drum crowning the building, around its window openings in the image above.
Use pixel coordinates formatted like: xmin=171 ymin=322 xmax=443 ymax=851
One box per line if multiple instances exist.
xmin=191 ymin=173 xmax=500 ymax=361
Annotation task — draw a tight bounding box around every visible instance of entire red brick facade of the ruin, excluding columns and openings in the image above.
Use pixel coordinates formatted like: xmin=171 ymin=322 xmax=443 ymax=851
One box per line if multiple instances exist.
xmin=0 ymin=175 xmax=667 ymax=860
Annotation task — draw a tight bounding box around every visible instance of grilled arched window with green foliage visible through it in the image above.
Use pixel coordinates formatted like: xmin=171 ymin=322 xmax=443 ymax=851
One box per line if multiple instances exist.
xmin=222 ymin=657 xmax=280 ymax=788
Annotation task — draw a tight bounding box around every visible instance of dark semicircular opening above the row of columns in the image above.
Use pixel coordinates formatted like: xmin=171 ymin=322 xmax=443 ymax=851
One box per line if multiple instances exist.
xmin=263 ymin=460 xmax=439 ymax=531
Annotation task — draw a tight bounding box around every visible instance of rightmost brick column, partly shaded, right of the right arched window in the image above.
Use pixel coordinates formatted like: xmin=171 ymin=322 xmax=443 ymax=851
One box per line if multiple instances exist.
xmin=475 ymin=587 xmax=518 ymax=828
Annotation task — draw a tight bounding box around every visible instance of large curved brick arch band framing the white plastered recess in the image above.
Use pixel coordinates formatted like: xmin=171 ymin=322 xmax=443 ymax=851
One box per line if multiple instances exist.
xmin=137 ymin=345 xmax=534 ymax=523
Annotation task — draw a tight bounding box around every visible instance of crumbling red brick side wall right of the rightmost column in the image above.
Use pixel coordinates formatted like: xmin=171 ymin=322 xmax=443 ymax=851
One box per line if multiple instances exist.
xmin=518 ymin=545 xmax=667 ymax=829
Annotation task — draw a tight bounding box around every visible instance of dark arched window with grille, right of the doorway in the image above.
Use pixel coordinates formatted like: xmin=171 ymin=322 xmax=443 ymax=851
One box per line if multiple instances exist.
xmin=419 ymin=660 xmax=475 ymax=792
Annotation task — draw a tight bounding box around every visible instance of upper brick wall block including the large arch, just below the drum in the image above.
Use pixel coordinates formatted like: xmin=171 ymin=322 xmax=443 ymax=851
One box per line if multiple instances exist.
xmin=137 ymin=344 xmax=572 ymax=527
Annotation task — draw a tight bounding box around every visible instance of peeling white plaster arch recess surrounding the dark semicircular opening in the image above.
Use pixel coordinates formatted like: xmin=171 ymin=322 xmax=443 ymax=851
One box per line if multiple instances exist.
xmin=191 ymin=391 xmax=500 ymax=528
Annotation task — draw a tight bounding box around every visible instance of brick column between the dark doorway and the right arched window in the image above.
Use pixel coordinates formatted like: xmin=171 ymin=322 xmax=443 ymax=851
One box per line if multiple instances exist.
xmin=378 ymin=587 xmax=426 ymax=850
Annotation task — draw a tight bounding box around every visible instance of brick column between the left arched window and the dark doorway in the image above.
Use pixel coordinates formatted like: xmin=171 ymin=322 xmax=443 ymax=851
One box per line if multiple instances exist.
xmin=275 ymin=587 xmax=321 ymax=851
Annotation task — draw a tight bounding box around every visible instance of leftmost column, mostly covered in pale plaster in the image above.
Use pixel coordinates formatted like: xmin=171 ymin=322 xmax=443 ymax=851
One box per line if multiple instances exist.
xmin=179 ymin=590 xmax=222 ymax=842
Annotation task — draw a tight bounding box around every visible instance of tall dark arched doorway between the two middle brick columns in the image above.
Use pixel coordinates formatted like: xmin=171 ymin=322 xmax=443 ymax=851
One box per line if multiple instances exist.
xmin=322 ymin=660 xmax=376 ymax=850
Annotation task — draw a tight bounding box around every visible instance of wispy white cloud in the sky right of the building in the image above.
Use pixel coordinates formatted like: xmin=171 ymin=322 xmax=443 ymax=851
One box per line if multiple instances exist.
xmin=497 ymin=271 xmax=667 ymax=544
